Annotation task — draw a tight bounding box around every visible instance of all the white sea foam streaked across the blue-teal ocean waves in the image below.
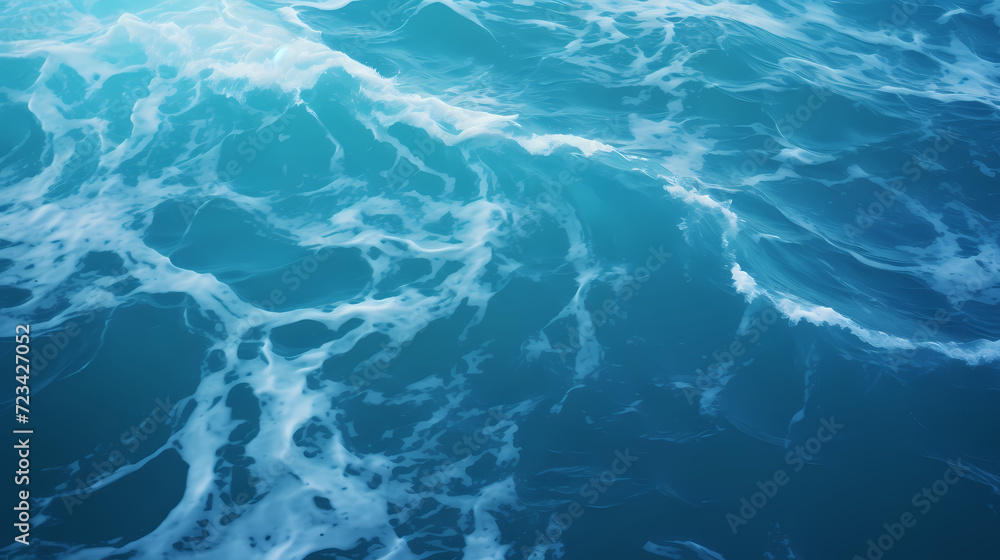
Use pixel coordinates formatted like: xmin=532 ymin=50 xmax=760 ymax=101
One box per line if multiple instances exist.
xmin=0 ymin=0 xmax=1000 ymax=559
